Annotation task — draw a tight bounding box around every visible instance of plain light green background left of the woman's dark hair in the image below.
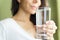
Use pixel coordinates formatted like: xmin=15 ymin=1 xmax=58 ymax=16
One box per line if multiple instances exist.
xmin=0 ymin=0 xmax=11 ymax=20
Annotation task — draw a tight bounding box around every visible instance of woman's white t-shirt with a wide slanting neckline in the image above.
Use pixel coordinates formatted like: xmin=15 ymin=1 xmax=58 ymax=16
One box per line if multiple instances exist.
xmin=0 ymin=18 xmax=40 ymax=40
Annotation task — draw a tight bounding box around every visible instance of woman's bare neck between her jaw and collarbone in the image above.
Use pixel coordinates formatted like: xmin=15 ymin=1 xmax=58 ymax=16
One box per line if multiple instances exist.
xmin=13 ymin=8 xmax=30 ymax=22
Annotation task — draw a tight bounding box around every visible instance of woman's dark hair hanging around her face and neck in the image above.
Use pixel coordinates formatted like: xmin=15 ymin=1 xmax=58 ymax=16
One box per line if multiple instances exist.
xmin=11 ymin=0 xmax=45 ymax=25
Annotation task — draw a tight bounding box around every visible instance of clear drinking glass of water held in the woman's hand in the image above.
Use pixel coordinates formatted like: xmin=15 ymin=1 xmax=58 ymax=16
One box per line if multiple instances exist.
xmin=36 ymin=7 xmax=51 ymax=40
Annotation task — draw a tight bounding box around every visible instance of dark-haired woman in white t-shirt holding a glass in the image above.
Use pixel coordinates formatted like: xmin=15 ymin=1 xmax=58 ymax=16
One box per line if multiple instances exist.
xmin=0 ymin=0 xmax=57 ymax=40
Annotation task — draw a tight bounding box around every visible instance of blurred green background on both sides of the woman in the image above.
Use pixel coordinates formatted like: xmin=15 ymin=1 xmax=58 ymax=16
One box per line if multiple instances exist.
xmin=0 ymin=0 xmax=60 ymax=40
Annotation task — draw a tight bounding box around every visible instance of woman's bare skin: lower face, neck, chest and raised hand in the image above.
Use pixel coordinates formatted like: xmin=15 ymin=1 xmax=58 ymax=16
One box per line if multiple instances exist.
xmin=12 ymin=0 xmax=57 ymax=40
